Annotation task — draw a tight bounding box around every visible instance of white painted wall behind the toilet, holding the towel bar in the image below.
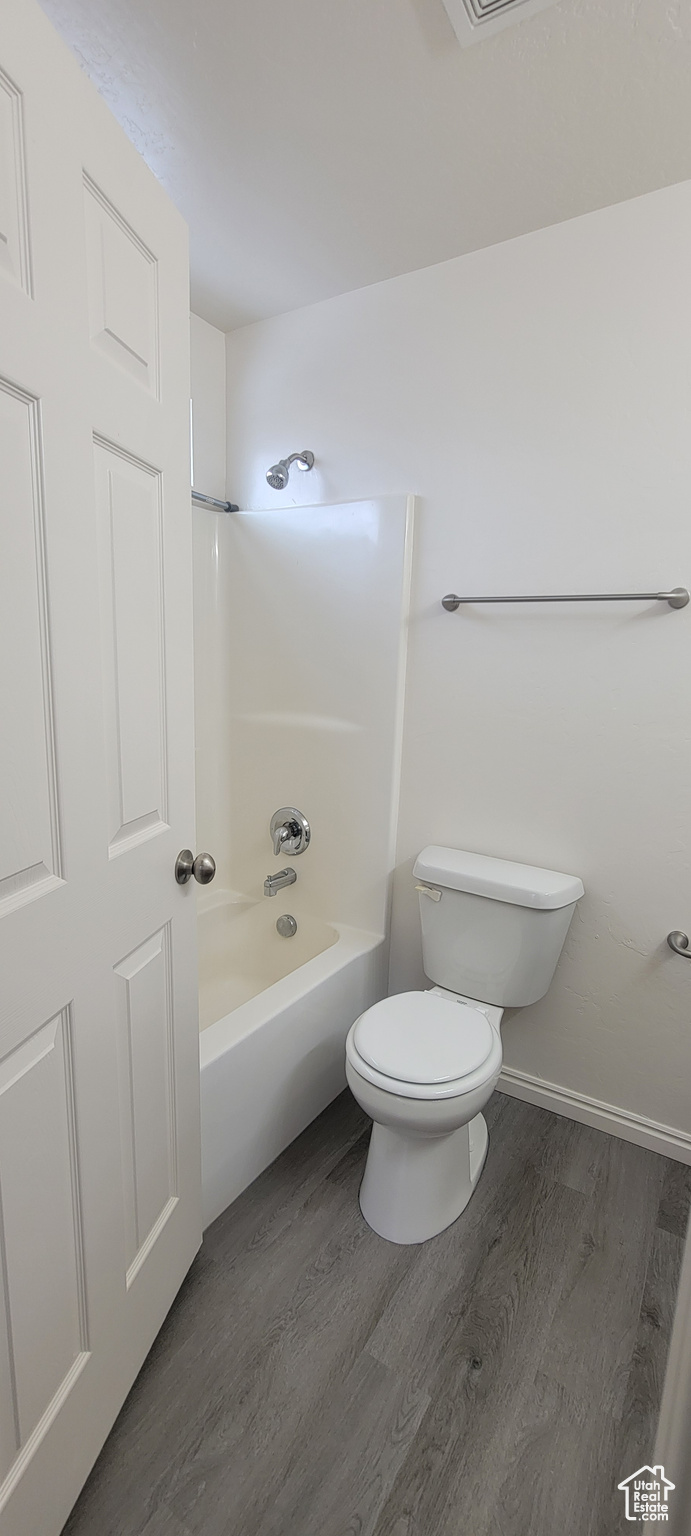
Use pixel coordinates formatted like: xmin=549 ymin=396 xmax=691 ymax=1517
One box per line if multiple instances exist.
xmin=227 ymin=184 xmax=691 ymax=1132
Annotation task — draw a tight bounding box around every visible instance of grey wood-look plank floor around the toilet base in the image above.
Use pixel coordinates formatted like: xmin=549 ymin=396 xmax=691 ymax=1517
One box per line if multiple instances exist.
xmin=64 ymin=1094 xmax=691 ymax=1536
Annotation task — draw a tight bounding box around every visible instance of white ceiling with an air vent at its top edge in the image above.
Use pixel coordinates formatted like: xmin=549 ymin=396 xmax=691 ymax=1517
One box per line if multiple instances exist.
xmin=41 ymin=0 xmax=691 ymax=330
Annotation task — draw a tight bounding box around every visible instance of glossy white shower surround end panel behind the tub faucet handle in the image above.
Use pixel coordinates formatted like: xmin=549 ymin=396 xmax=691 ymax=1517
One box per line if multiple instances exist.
xmin=220 ymin=497 xmax=412 ymax=934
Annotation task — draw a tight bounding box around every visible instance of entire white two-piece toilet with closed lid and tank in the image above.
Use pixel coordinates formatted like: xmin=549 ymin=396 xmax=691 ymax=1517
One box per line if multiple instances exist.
xmin=346 ymin=846 xmax=584 ymax=1243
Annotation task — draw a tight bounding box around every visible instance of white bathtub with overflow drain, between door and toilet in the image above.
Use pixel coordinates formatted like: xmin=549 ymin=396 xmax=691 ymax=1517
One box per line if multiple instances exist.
xmin=200 ymin=886 xmax=387 ymax=1226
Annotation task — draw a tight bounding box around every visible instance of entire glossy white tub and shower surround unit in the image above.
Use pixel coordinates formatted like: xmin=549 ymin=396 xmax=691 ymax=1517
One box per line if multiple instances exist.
xmin=195 ymin=496 xmax=413 ymax=1223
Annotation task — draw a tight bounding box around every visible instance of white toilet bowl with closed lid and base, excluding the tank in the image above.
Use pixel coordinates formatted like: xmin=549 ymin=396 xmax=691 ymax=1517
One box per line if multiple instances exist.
xmin=346 ymin=988 xmax=502 ymax=1243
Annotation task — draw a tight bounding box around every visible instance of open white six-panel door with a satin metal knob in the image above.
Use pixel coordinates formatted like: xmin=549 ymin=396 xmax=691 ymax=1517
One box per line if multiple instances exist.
xmin=0 ymin=0 xmax=201 ymax=1536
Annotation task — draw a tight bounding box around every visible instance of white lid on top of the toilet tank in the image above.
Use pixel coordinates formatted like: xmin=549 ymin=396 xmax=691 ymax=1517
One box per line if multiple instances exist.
xmin=413 ymin=843 xmax=584 ymax=911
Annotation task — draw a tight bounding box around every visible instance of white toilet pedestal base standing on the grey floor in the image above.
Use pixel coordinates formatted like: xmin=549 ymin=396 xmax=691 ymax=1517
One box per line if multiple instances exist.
xmin=359 ymin=1115 xmax=490 ymax=1243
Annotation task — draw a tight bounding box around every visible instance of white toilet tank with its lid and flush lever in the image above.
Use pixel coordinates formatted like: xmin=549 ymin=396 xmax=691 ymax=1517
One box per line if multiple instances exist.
xmin=413 ymin=845 xmax=584 ymax=1008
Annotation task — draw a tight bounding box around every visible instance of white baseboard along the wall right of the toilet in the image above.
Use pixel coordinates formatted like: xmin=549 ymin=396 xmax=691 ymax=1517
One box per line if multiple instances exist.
xmin=496 ymin=1066 xmax=691 ymax=1163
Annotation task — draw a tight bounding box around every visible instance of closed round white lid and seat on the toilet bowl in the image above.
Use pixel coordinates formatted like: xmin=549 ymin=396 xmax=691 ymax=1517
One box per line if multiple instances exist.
xmin=346 ymin=992 xmax=502 ymax=1100
